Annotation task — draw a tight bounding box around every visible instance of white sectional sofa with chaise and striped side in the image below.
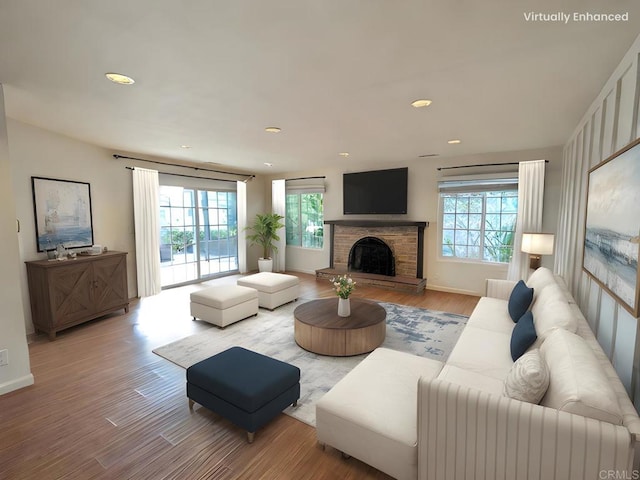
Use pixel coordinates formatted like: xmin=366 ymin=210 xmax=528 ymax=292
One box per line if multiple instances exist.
xmin=316 ymin=268 xmax=640 ymax=480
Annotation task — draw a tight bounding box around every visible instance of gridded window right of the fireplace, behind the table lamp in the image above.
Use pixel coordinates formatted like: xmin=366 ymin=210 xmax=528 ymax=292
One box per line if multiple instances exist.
xmin=439 ymin=176 xmax=518 ymax=263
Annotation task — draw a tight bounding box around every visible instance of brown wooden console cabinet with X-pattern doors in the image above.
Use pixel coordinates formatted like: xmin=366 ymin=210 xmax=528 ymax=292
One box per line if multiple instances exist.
xmin=26 ymin=252 xmax=129 ymax=340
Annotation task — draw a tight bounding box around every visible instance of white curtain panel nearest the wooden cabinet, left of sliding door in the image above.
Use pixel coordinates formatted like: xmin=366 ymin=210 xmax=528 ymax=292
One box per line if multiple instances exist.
xmin=133 ymin=167 xmax=161 ymax=297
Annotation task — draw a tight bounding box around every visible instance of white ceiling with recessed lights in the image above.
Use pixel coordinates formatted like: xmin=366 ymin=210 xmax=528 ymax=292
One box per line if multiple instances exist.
xmin=0 ymin=0 xmax=640 ymax=173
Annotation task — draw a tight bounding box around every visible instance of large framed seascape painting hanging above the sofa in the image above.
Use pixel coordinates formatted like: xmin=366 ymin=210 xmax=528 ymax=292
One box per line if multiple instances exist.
xmin=582 ymin=139 xmax=640 ymax=317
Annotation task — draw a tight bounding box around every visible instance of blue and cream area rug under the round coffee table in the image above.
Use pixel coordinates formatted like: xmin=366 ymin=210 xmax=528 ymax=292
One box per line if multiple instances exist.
xmin=153 ymin=300 xmax=467 ymax=426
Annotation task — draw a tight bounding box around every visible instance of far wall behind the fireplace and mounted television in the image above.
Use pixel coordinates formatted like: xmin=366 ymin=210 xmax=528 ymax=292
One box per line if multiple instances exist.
xmin=265 ymin=147 xmax=562 ymax=295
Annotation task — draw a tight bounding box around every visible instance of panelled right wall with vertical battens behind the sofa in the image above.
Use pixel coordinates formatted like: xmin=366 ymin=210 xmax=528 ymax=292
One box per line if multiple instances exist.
xmin=557 ymin=31 xmax=640 ymax=408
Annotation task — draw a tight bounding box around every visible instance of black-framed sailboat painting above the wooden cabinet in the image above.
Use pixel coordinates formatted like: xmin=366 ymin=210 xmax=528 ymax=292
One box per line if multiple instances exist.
xmin=31 ymin=177 xmax=93 ymax=252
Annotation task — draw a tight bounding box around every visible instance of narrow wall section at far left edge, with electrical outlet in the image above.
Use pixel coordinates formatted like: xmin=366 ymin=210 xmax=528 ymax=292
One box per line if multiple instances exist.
xmin=0 ymin=85 xmax=33 ymax=395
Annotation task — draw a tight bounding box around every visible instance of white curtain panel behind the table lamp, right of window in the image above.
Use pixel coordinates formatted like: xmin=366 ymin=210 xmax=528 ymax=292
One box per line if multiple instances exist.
xmin=507 ymin=160 xmax=545 ymax=280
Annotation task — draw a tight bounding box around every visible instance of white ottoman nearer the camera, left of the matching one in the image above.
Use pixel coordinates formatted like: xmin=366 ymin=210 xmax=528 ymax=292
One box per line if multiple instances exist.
xmin=191 ymin=285 xmax=258 ymax=327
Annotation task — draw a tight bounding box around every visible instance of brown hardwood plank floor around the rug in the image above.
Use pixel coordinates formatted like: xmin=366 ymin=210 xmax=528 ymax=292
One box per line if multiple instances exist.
xmin=0 ymin=274 xmax=478 ymax=480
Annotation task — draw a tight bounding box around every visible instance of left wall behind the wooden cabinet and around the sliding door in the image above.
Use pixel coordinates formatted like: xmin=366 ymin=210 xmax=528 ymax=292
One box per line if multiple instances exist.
xmin=7 ymin=119 xmax=263 ymax=333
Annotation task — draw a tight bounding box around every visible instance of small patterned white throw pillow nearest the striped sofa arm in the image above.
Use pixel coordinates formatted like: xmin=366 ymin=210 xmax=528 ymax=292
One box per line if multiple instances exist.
xmin=503 ymin=348 xmax=549 ymax=403
